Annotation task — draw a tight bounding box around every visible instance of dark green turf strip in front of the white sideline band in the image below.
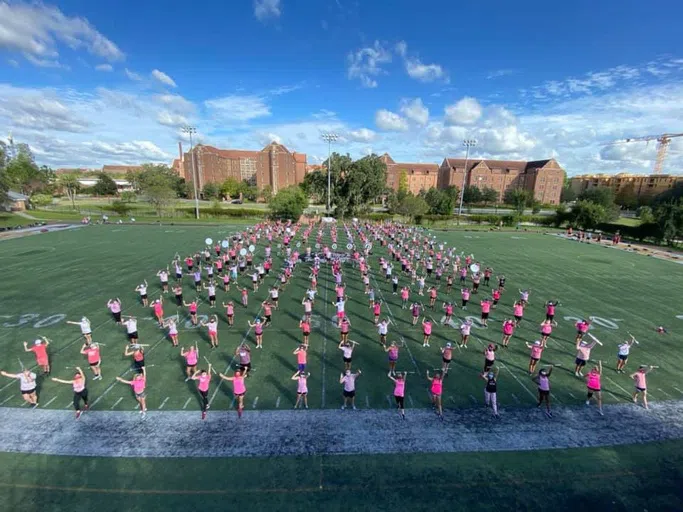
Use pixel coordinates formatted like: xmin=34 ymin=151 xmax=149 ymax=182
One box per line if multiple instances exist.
xmin=0 ymin=440 xmax=683 ymax=511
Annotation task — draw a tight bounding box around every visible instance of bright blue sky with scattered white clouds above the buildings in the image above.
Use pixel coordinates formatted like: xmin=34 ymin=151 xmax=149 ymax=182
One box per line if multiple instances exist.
xmin=0 ymin=0 xmax=683 ymax=175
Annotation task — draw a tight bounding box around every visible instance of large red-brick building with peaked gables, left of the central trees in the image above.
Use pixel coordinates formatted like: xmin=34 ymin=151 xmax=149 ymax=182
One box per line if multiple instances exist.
xmin=179 ymin=142 xmax=306 ymax=193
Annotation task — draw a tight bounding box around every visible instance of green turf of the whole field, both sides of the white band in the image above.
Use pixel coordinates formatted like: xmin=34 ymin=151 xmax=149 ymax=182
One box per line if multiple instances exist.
xmin=0 ymin=225 xmax=683 ymax=510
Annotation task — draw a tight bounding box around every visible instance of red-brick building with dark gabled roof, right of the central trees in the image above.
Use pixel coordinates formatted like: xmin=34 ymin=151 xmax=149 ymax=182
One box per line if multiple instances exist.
xmin=437 ymin=158 xmax=564 ymax=204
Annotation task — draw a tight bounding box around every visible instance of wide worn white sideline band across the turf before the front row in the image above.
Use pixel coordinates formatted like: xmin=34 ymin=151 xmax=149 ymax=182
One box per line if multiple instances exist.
xmin=0 ymin=402 xmax=683 ymax=457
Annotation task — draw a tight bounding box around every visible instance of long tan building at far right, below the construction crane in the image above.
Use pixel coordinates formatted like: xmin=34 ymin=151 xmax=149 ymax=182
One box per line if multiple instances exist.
xmin=569 ymin=173 xmax=683 ymax=199
